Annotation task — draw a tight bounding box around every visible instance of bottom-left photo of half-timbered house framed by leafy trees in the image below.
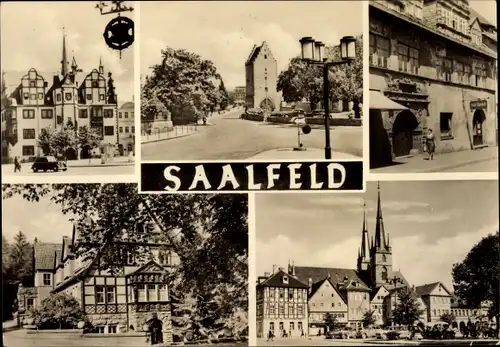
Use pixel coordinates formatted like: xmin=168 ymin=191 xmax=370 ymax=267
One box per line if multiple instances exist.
xmin=2 ymin=184 xmax=248 ymax=347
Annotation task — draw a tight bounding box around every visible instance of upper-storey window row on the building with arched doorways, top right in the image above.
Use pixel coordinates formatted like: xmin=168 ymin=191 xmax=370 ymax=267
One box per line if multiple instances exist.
xmin=370 ymin=34 xmax=494 ymax=87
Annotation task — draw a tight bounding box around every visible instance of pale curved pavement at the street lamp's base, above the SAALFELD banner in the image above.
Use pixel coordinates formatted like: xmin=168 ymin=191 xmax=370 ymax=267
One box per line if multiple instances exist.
xmin=252 ymin=148 xmax=363 ymax=160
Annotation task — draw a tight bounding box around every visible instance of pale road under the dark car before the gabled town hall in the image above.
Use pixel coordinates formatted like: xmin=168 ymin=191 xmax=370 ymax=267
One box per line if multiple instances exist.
xmin=2 ymin=164 xmax=135 ymax=180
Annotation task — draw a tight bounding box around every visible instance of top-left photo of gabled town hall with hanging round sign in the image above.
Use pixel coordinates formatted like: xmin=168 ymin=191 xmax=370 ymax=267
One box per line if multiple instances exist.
xmin=1 ymin=1 xmax=135 ymax=178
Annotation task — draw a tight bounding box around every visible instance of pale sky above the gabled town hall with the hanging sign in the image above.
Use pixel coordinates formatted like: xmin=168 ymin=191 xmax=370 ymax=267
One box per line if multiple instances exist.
xmin=1 ymin=1 xmax=134 ymax=103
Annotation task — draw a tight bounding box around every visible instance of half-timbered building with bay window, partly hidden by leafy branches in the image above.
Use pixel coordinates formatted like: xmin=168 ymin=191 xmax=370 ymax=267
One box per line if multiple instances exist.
xmin=18 ymin=225 xmax=178 ymax=342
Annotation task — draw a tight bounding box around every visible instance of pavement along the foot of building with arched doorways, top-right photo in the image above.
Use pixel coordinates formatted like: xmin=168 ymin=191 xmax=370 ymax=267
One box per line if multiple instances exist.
xmin=371 ymin=146 xmax=498 ymax=173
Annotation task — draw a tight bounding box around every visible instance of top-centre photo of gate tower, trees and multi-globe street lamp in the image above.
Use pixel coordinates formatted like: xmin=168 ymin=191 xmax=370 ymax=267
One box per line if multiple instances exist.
xmin=140 ymin=1 xmax=365 ymax=161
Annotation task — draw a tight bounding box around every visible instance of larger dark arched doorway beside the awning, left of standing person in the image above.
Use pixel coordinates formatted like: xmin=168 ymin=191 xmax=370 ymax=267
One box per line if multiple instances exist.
xmin=392 ymin=110 xmax=418 ymax=157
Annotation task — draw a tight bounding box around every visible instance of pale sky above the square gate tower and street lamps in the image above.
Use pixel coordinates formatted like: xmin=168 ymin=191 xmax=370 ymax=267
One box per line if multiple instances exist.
xmin=140 ymin=1 xmax=363 ymax=89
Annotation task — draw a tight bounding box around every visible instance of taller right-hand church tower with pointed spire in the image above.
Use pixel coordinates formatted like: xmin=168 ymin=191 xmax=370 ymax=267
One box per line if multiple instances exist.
xmin=370 ymin=183 xmax=392 ymax=287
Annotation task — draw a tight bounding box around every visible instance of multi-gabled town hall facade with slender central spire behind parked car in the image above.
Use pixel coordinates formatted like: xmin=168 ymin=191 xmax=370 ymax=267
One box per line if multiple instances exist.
xmin=2 ymin=37 xmax=118 ymax=160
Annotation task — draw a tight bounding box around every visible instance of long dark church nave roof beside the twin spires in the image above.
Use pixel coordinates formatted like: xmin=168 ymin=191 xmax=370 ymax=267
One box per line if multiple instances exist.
xmin=295 ymin=266 xmax=369 ymax=288
